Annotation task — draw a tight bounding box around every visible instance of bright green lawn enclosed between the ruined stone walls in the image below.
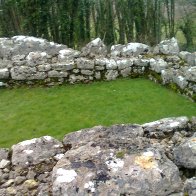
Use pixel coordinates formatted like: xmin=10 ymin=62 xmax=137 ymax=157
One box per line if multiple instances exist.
xmin=0 ymin=79 xmax=196 ymax=147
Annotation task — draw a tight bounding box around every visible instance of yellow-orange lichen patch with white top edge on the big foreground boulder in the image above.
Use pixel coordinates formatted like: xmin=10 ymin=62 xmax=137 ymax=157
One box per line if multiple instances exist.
xmin=134 ymin=152 xmax=157 ymax=169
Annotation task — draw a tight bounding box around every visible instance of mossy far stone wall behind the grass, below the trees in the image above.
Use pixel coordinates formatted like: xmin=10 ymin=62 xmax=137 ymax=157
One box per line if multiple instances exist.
xmin=0 ymin=36 xmax=196 ymax=100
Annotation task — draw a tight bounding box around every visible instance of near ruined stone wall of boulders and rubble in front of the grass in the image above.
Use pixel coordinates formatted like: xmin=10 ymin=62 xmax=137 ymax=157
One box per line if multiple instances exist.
xmin=0 ymin=117 xmax=196 ymax=196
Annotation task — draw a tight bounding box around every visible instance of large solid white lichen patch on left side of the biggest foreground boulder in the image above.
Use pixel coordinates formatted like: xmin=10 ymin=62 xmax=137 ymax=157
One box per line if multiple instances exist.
xmin=56 ymin=168 xmax=77 ymax=183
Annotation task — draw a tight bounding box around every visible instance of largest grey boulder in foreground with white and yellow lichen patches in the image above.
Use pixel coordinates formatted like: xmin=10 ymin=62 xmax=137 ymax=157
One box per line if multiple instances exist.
xmin=53 ymin=146 xmax=181 ymax=196
